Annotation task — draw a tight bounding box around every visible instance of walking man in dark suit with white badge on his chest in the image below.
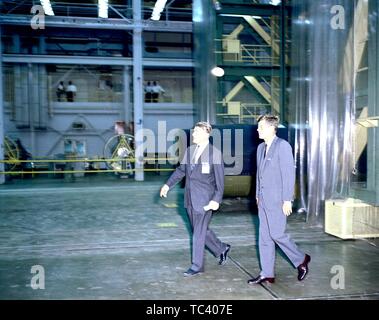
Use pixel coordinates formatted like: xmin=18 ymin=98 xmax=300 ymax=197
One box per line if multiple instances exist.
xmin=160 ymin=122 xmax=230 ymax=277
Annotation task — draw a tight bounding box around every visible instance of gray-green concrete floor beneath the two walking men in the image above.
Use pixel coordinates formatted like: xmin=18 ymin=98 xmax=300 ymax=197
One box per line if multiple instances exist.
xmin=0 ymin=175 xmax=379 ymax=300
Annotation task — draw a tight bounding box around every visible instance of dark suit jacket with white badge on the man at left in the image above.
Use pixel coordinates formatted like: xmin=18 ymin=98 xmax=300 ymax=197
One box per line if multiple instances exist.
xmin=166 ymin=144 xmax=224 ymax=213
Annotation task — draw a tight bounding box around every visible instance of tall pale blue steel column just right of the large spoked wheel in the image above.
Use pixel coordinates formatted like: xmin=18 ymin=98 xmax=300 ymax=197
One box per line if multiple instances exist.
xmin=133 ymin=0 xmax=144 ymax=181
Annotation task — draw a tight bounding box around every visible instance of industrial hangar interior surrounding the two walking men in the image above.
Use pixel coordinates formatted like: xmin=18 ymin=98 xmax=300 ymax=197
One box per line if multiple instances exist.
xmin=0 ymin=0 xmax=379 ymax=300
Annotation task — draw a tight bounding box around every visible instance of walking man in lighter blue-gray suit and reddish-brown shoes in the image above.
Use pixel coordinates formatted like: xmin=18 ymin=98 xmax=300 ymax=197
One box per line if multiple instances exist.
xmin=248 ymin=115 xmax=311 ymax=284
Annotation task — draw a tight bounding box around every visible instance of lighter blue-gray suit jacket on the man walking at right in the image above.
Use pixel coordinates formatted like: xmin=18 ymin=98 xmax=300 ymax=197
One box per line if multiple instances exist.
xmin=256 ymin=137 xmax=295 ymax=208
